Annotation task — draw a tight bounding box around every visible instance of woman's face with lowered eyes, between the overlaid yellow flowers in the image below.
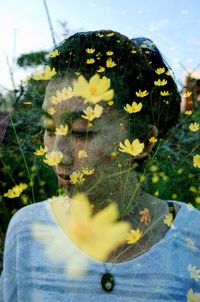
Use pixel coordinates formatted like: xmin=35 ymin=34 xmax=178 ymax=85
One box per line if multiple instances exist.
xmin=43 ymin=78 xmax=128 ymax=198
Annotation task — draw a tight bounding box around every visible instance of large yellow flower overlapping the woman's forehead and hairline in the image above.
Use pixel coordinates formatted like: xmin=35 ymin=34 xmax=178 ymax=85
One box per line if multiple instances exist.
xmin=74 ymin=74 xmax=114 ymax=104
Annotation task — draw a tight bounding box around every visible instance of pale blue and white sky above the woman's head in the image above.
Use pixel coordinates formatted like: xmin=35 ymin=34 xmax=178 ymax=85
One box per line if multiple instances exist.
xmin=0 ymin=0 xmax=200 ymax=90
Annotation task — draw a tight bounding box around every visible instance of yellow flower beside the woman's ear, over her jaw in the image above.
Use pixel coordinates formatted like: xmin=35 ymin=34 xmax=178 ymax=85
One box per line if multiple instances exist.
xmin=119 ymin=139 xmax=144 ymax=156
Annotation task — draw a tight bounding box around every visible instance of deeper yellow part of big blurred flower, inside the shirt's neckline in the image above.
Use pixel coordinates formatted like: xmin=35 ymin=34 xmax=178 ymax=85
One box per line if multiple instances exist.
xmin=66 ymin=194 xmax=130 ymax=261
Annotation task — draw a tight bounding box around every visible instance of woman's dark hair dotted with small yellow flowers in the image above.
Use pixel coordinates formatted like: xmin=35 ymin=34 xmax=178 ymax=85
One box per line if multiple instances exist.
xmin=48 ymin=30 xmax=181 ymax=137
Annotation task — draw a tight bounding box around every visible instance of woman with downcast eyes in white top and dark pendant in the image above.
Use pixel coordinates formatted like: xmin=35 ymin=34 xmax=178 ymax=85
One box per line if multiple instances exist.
xmin=1 ymin=31 xmax=200 ymax=301
